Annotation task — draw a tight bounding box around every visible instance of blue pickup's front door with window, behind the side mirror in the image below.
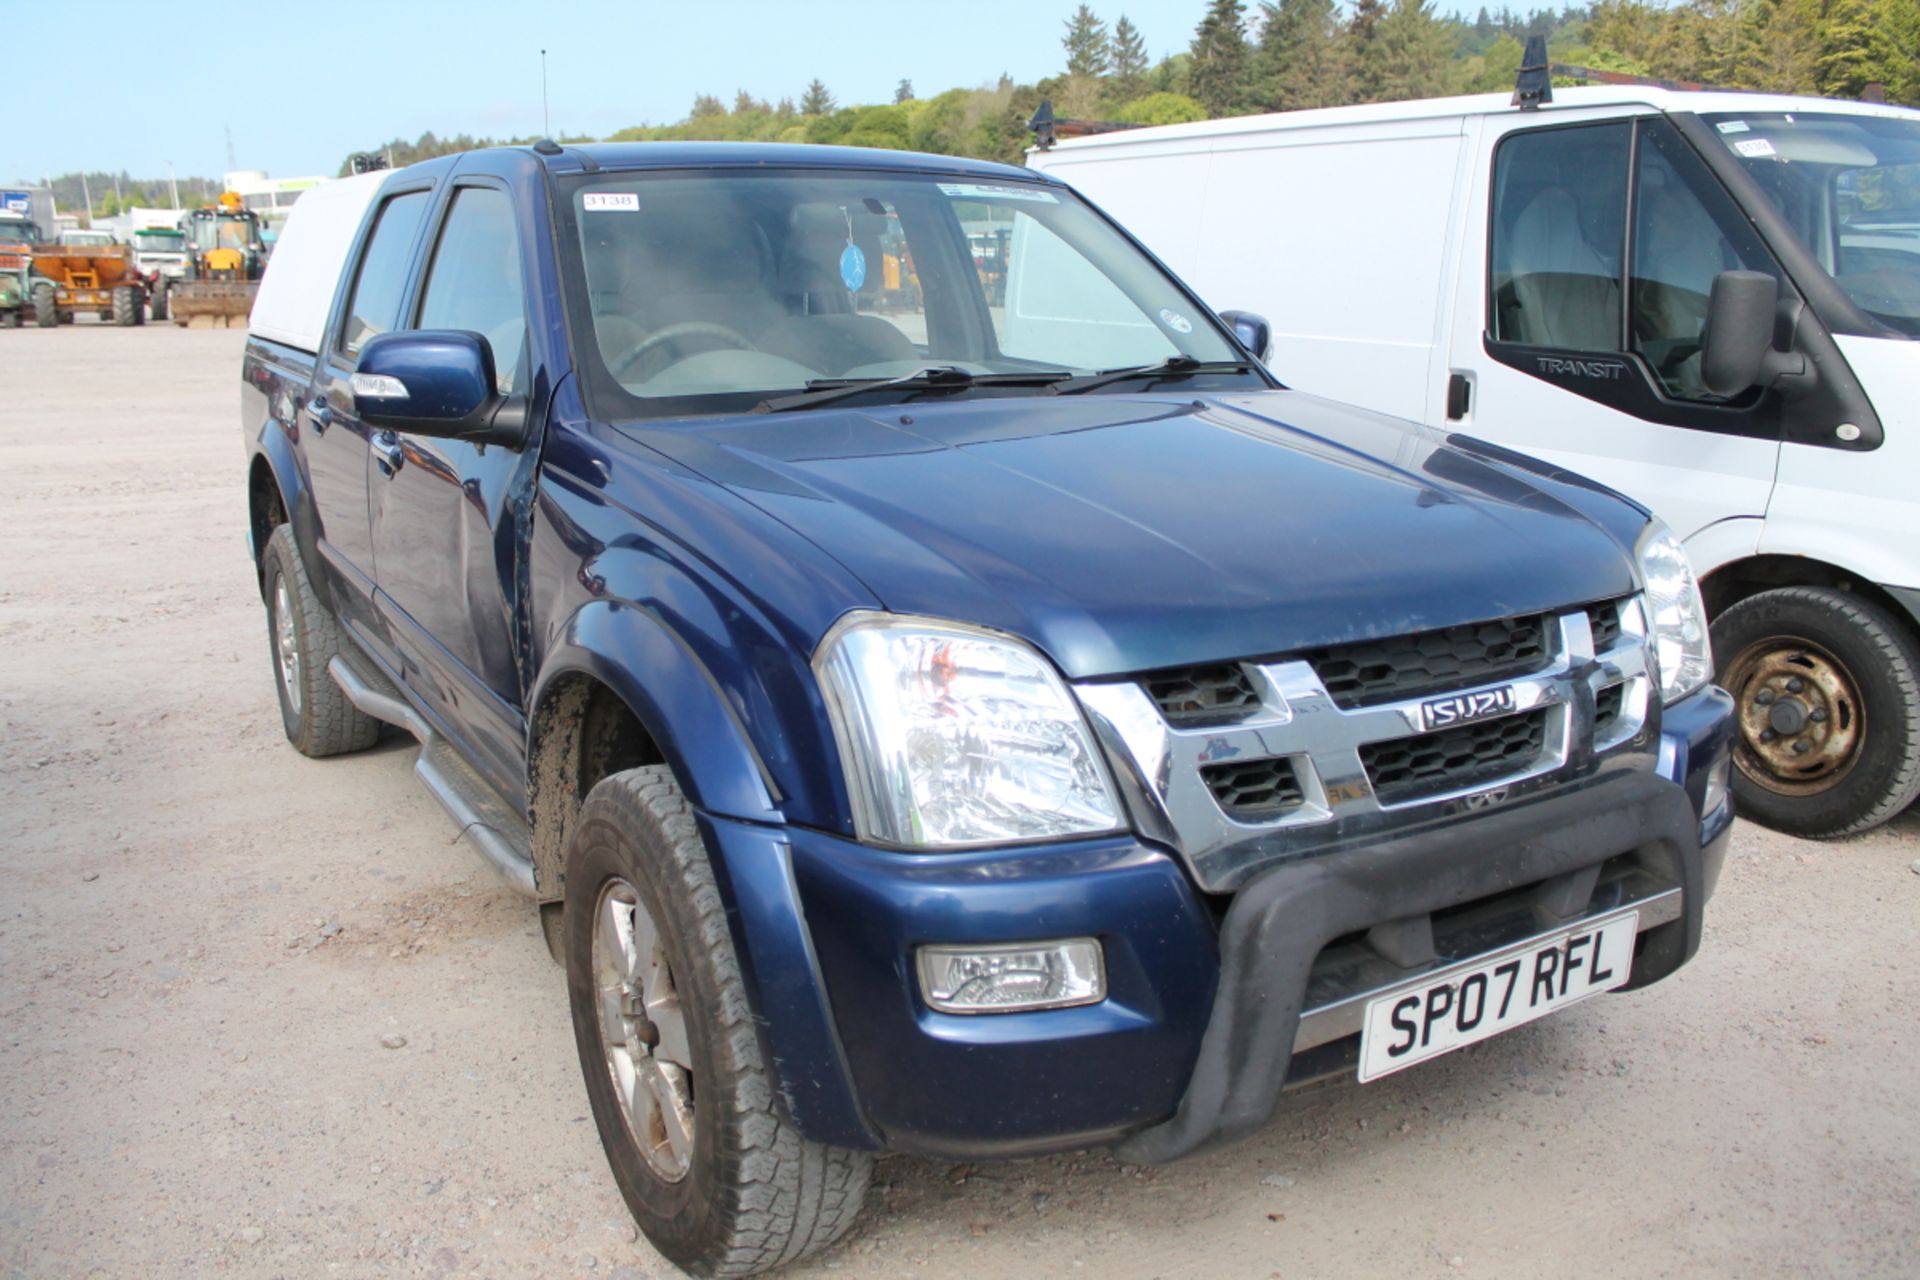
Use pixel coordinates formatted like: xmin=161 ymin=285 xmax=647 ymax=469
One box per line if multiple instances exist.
xmin=369 ymin=178 xmax=536 ymax=796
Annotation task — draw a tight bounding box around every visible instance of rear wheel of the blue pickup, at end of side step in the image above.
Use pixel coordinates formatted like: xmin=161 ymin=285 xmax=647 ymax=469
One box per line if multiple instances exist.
xmin=263 ymin=524 xmax=380 ymax=756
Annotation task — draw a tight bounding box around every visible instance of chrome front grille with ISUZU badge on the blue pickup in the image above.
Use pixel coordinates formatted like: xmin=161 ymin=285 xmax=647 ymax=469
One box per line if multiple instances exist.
xmin=1073 ymin=597 xmax=1659 ymax=892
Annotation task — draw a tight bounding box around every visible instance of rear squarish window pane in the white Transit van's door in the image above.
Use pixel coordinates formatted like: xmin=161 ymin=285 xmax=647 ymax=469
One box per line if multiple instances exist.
xmin=1492 ymin=121 xmax=1632 ymax=351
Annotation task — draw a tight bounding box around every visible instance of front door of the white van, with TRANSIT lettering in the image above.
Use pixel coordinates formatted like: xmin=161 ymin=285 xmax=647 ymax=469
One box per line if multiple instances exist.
xmin=1446 ymin=113 xmax=1784 ymax=549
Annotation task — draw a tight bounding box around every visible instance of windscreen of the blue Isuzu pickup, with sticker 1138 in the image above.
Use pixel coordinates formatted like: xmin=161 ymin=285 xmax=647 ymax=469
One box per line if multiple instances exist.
xmin=566 ymin=169 xmax=1258 ymax=416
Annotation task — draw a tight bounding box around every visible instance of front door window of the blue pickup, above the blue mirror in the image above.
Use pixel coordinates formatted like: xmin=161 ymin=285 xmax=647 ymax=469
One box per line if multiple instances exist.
xmin=417 ymin=186 xmax=526 ymax=395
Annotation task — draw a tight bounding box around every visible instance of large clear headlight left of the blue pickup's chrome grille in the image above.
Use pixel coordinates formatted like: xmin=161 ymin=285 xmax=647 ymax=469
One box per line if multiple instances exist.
xmin=814 ymin=614 xmax=1121 ymax=848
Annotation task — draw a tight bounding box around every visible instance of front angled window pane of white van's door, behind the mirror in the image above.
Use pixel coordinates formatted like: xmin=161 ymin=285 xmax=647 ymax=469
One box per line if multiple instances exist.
xmin=1628 ymin=121 xmax=1780 ymax=401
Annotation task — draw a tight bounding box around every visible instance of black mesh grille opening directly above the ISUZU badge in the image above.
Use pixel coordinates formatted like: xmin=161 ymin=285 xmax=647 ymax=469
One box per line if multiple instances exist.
xmin=1300 ymin=614 xmax=1549 ymax=710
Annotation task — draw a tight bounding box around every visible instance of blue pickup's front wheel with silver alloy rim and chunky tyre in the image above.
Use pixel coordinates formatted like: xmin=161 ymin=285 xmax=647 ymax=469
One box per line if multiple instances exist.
xmin=561 ymin=766 xmax=872 ymax=1276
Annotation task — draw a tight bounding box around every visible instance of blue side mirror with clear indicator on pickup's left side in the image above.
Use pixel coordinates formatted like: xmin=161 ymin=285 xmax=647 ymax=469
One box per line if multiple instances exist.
xmin=353 ymin=328 xmax=524 ymax=445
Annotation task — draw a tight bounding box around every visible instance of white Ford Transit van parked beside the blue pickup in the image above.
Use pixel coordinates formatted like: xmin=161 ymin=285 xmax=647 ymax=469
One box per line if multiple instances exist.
xmin=1027 ymin=86 xmax=1920 ymax=837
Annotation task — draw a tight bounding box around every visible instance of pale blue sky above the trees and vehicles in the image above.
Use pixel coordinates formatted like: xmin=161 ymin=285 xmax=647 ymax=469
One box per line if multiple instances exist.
xmin=15 ymin=0 xmax=1459 ymax=180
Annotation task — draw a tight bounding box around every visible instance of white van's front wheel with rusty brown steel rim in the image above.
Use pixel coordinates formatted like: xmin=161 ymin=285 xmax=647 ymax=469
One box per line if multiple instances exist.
xmin=1713 ymin=587 xmax=1920 ymax=839
